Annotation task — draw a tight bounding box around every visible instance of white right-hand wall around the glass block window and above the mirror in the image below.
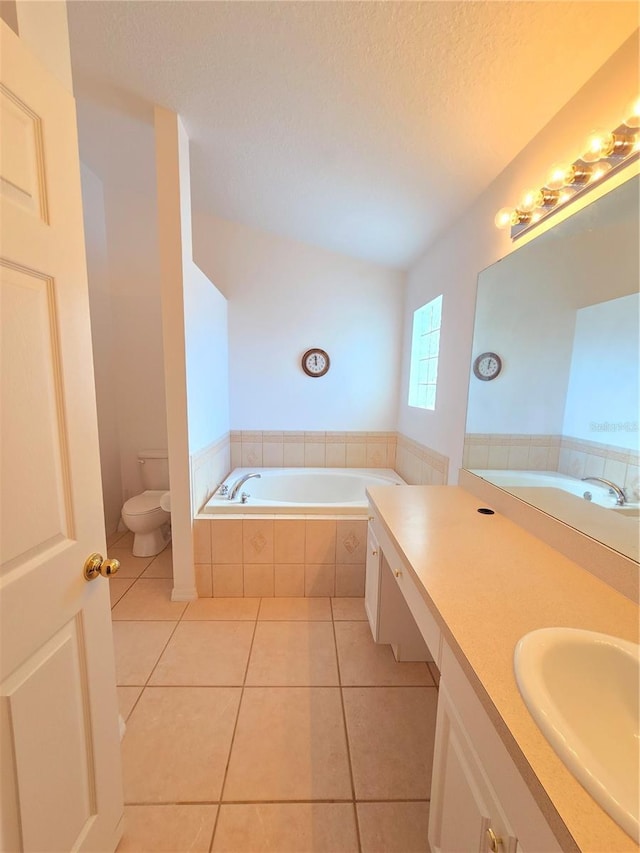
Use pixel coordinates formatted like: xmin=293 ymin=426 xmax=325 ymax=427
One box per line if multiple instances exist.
xmin=398 ymin=33 xmax=638 ymax=483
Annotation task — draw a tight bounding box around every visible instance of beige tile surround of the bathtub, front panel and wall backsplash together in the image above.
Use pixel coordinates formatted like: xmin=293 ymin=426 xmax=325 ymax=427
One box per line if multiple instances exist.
xmin=191 ymin=431 xmax=449 ymax=598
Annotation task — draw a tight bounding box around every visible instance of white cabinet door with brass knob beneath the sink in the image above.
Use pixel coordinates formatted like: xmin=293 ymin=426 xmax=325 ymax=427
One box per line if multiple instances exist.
xmin=429 ymin=683 xmax=516 ymax=853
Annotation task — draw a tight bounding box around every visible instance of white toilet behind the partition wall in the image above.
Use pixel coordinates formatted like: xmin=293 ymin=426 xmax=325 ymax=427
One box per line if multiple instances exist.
xmin=122 ymin=450 xmax=171 ymax=557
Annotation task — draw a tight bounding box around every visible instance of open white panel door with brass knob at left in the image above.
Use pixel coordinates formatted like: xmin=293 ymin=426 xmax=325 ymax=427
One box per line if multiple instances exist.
xmin=0 ymin=21 xmax=123 ymax=853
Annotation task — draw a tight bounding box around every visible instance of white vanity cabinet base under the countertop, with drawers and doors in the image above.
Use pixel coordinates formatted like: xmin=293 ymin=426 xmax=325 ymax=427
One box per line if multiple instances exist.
xmin=365 ymin=512 xmax=562 ymax=853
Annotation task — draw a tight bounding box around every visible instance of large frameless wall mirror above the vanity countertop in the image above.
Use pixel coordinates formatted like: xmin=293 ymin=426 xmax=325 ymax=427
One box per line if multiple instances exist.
xmin=463 ymin=177 xmax=640 ymax=561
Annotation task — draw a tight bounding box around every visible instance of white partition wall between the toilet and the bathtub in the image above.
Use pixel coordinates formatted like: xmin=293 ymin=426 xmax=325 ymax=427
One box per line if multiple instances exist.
xmin=154 ymin=106 xmax=229 ymax=601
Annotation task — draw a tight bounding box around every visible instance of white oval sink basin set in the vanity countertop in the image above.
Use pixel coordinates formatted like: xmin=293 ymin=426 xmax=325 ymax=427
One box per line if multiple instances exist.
xmin=514 ymin=628 xmax=640 ymax=842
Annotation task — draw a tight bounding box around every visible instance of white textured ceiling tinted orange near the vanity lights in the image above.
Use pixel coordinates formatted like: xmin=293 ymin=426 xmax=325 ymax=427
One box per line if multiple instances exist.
xmin=68 ymin=0 xmax=638 ymax=267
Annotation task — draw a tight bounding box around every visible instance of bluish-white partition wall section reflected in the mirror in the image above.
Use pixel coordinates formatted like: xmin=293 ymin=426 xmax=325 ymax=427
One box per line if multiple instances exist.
xmin=564 ymin=294 xmax=640 ymax=452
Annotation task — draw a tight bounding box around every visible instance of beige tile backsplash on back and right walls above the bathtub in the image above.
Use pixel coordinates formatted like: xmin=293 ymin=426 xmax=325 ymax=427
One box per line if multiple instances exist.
xmin=231 ymin=431 xmax=449 ymax=486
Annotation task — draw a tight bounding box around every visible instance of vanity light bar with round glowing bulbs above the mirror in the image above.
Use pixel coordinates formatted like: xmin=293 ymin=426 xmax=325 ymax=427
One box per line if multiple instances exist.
xmin=495 ymin=97 xmax=640 ymax=240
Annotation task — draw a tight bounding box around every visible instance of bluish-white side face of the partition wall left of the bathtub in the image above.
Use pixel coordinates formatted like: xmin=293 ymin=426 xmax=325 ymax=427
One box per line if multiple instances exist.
xmin=184 ymin=261 xmax=229 ymax=456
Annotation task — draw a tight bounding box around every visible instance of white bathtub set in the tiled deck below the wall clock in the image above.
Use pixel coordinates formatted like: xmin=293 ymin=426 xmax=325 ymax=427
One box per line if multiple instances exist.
xmin=201 ymin=468 xmax=404 ymax=515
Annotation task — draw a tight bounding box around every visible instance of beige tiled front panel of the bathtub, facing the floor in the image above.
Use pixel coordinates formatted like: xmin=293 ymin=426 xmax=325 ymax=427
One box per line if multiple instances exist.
xmin=194 ymin=516 xmax=367 ymax=597
